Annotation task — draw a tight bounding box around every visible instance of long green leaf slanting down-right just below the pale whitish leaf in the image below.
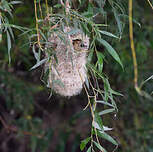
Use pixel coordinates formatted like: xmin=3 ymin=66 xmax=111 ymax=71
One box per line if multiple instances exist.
xmin=97 ymin=130 xmax=118 ymax=146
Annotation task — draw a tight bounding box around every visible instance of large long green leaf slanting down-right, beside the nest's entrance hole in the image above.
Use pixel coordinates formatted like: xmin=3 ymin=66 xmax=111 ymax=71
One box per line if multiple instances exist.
xmin=97 ymin=39 xmax=123 ymax=68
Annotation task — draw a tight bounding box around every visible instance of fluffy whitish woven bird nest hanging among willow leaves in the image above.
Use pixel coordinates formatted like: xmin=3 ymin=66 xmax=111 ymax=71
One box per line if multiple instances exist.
xmin=45 ymin=27 xmax=89 ymax=96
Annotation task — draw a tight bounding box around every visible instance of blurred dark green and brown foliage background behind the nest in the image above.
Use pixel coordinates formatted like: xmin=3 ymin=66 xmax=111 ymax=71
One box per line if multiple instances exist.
xmin=0 ymin=0 xmax=153 ymax=152
